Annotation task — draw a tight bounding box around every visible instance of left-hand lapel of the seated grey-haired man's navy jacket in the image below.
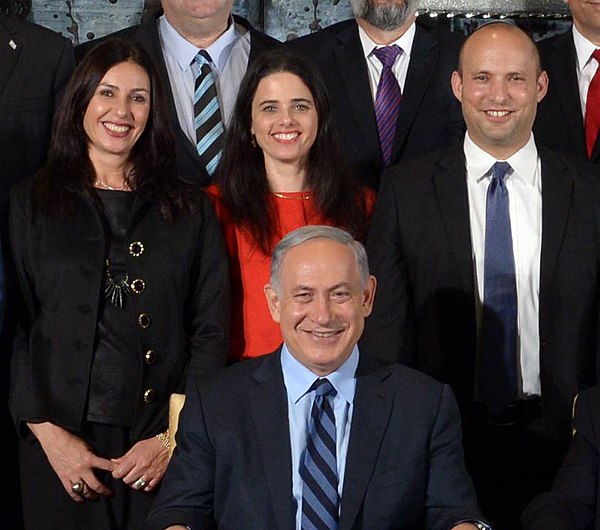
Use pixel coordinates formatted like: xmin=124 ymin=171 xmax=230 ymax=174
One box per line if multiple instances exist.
xmin=250 ymin=350 xmax=296 ymax=530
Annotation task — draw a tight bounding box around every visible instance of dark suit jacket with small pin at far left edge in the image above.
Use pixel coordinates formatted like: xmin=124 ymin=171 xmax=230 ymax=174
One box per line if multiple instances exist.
xmin=0 ymin=12 xmax=75 ymax=210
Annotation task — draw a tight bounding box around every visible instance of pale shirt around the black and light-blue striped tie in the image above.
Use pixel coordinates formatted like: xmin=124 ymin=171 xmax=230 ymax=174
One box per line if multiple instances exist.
xmin=158 ymin=15 xmax=250 ymax=145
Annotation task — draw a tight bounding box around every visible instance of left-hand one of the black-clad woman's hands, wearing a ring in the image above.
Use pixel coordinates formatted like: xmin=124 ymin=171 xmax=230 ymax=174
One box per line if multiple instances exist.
xmin=27 ymin=422 xmax=115 ymax=504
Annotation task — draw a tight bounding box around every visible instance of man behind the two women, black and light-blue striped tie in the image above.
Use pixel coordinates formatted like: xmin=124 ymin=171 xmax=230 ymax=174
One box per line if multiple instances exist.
xmin=76 ymin=0 xmax=281 ymax=186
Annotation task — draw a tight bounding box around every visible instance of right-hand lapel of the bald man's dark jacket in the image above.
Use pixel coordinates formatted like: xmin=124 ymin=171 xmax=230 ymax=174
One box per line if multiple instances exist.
xmin=539 ymin=147 xmax=573 ymax=276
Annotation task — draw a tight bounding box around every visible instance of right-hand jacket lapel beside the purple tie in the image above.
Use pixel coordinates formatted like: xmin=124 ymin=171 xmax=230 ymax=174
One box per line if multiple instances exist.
xmin=392 ymin=25 xmax=436 ymax=160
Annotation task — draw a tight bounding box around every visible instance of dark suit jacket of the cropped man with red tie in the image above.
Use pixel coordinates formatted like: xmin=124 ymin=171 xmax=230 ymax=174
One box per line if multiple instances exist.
xmin=533 ymin=30 xmax=600 ymax=164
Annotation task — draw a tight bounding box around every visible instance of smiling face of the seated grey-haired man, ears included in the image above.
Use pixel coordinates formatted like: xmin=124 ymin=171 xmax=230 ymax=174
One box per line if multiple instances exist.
xmin=265 ymin=238 xmax=375 ymax=376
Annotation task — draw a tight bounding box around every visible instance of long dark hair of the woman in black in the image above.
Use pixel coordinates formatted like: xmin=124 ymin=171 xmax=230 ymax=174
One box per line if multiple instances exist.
xmin=34 ymin=39 xmax=199 ymax=221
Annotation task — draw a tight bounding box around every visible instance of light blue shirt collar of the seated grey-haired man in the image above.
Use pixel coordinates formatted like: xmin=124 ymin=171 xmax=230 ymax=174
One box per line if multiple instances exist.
xmin=281 ymin=343 xmax=359 ymax=404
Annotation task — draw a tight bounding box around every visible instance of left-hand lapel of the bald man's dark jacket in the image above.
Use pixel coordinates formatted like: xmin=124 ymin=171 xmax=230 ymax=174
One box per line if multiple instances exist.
xmin=433 ymin=144 xmax=473 ymax=292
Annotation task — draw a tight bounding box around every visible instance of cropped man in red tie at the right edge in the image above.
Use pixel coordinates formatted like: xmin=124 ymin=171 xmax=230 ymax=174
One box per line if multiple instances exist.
xmin=534 ymin=0 xmax=600 ymax=164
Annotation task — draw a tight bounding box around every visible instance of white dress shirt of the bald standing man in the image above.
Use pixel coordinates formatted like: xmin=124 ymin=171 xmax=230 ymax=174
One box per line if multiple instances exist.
xmin=464 ymin=134 xmax=542 ymax=397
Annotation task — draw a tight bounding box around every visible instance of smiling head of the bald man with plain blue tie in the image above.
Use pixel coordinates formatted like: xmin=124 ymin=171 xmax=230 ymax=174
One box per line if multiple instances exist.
xmin=452 ymin=23 xmax=548 ymax=160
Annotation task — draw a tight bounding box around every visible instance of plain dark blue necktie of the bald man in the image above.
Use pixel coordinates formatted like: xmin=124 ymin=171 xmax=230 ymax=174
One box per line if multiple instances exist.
xmin=479 ymin=162 xmax=517 ymax=414
